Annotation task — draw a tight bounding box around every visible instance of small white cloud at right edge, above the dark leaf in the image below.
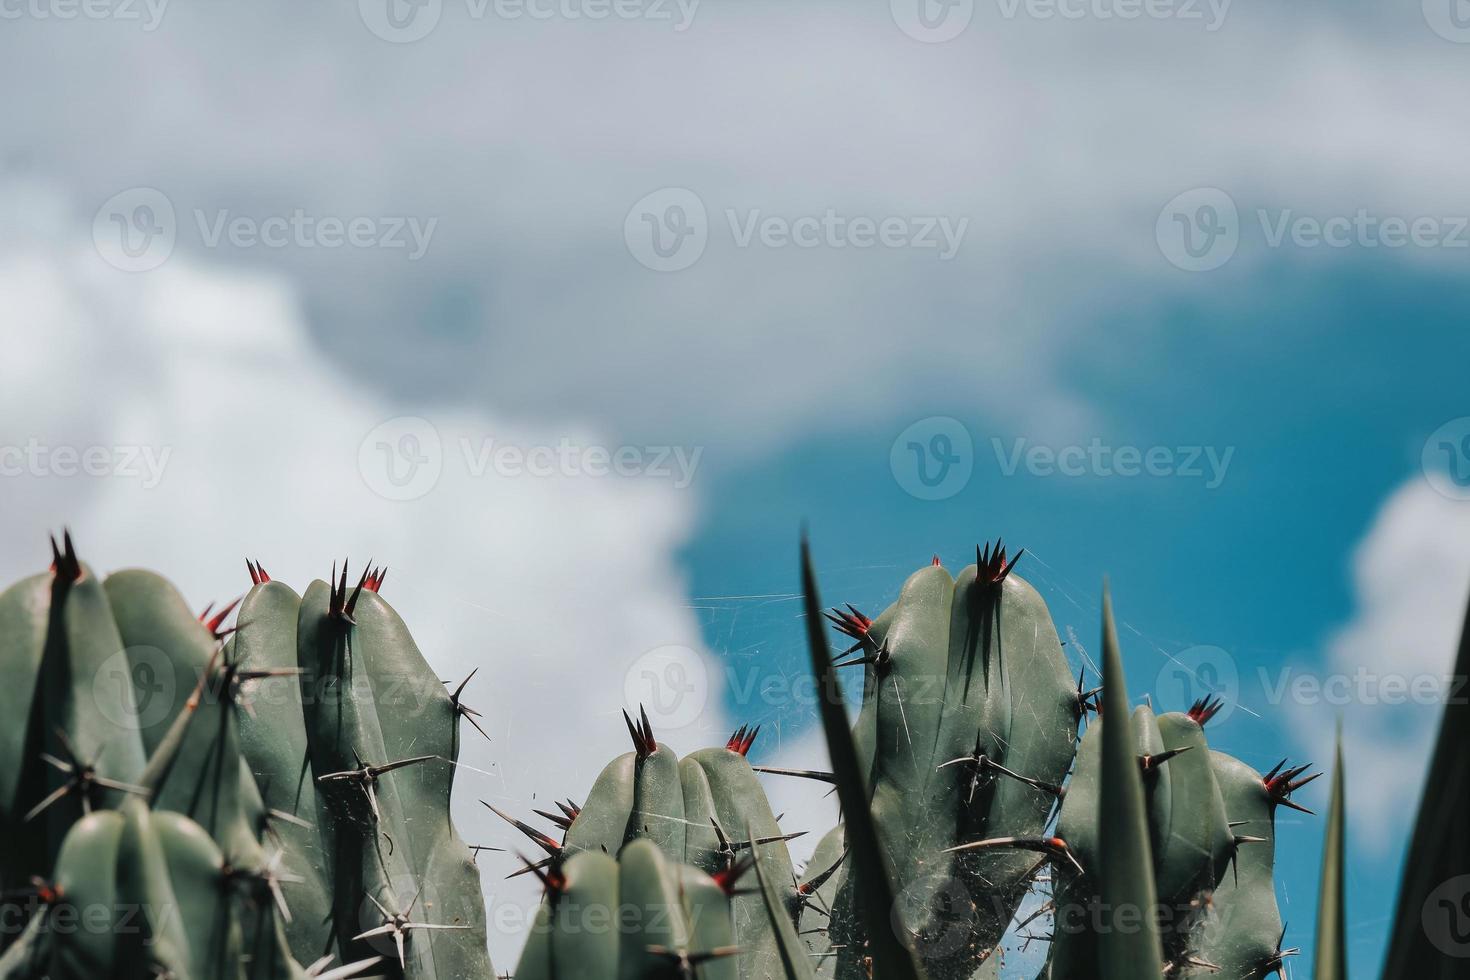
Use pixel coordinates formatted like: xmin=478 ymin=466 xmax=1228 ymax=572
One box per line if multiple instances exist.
xmin=1289 ymin=478 xmax=1470 ymax=849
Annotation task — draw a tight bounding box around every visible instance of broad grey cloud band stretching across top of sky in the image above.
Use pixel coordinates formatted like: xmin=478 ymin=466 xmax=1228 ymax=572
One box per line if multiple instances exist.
xmin=11 ymin=0 xmax=1470 ymax=448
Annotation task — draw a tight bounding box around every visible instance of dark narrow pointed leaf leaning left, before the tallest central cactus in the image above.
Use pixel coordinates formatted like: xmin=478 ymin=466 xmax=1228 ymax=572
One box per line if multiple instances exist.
xmin=801 ymin=538 xmax=925 ymax=980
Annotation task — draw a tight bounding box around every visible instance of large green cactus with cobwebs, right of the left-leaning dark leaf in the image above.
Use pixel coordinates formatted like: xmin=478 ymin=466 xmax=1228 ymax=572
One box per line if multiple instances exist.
xmin=782 ymin=542 xmax=1089 ymax=977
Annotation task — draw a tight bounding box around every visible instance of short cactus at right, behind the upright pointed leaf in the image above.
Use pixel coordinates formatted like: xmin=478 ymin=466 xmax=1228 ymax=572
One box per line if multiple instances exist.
xmin=1050 ymin=590 xmax=1314 ymax=980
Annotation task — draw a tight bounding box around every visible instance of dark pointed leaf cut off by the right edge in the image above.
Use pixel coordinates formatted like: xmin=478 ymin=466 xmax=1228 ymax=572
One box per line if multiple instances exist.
xmin=1383 ymin=587 xmax=1470 ymax=980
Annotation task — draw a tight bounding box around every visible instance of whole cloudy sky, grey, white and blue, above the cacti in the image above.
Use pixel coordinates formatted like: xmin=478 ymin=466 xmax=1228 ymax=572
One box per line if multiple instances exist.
xmin=0 ymin=0 xmax=1470 ymax=970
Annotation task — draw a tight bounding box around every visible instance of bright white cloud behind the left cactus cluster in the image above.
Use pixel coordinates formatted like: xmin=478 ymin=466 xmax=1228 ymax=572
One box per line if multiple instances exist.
xmin=0 ymin=188 xmax=729 ymax=968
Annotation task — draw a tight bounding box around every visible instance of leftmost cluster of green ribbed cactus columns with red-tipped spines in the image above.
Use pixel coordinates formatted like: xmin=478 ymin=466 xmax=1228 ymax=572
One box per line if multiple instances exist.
xmin=0 ymin=533 xmax=494 ymax=980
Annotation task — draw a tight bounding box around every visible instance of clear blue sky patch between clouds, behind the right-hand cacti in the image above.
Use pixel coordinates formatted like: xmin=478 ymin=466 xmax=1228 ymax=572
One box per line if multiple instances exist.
xmin=685 ymin=255 xmax=1467 ymax=973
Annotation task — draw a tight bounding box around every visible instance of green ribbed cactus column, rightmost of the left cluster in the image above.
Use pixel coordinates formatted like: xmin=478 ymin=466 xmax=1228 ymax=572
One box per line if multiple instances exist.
xmin=294 ymin=563 xmax=492 ymax=980
